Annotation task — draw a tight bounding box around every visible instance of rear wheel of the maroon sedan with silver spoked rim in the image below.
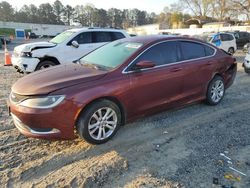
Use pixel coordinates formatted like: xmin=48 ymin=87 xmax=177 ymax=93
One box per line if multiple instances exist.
xmin=206 ymin=76 xmax=225 ymax=106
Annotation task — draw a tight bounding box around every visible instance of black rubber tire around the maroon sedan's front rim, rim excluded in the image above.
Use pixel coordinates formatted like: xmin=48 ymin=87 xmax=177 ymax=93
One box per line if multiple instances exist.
xmin=77 ymin=100 xmax=122 ymax=144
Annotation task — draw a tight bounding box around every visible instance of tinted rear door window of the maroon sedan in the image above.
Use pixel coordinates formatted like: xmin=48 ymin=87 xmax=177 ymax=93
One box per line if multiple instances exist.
xmin=180 ymin=41 xmax=206 ymax=60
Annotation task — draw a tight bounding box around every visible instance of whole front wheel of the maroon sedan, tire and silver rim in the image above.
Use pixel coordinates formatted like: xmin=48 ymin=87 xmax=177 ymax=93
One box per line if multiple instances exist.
xmin=77 ymin=100 xmax=122 ymax=144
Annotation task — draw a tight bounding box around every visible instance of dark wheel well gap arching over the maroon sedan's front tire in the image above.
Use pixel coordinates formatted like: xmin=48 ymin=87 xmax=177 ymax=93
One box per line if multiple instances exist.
xmin=75 ymin=96 xmax=126 ymax=126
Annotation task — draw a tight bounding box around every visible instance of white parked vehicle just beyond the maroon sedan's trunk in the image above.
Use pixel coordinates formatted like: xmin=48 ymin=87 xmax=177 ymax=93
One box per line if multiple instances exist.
xmin=208 ymin=33 xmax=237 ymax=54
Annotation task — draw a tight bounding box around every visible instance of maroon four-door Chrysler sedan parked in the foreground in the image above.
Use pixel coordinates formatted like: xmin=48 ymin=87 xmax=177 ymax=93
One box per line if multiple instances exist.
xmin=8 ymin=36 xmax=237 ymax=144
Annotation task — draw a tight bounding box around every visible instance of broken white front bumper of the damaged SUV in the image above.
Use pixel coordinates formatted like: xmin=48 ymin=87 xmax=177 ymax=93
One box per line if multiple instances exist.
xmin=11 ymin=55 xmax=40 ymax=73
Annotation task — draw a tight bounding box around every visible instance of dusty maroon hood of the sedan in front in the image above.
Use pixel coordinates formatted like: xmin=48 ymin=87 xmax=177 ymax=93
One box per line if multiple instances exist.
xmin=12 ymin=63 xmax=107 ymax=95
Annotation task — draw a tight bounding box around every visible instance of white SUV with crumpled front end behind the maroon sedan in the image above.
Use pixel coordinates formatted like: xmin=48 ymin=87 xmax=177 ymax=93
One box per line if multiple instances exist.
xmin=12 ymin=28 xmax=130 ymax=73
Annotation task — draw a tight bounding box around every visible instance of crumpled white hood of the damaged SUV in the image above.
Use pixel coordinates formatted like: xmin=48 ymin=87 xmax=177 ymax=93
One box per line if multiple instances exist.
xmin=14 ymin=42 xmax=56 ymax=52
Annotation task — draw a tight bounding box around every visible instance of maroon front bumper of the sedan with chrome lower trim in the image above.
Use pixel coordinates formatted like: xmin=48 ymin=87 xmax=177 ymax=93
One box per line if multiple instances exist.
xmin=7 ymin=97 xmax=79 ymax=139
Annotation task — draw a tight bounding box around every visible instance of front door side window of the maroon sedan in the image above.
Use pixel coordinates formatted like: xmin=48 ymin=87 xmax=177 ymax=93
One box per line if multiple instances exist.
xmin=135 ymin=41 xmax=179 ymax=66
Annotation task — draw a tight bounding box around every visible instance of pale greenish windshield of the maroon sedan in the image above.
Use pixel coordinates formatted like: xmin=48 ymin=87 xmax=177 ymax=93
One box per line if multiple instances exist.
xmin=79 ymin=41 xmax=143 ymax=70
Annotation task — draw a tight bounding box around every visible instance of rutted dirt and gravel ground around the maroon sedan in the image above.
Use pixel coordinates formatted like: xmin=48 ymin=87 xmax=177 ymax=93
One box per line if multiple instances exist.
xmin=0 ymin=48 xmax=250 ymax=188
